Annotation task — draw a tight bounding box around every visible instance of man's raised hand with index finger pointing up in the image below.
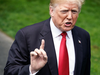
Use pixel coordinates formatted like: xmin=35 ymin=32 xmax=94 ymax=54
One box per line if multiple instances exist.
xmin=30 ymin=39 xmax=48 ymax=73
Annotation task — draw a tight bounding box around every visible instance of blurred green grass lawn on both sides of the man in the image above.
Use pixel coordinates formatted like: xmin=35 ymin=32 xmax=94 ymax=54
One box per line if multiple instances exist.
xmin=0 ymin=0 xmax=100 ymax=75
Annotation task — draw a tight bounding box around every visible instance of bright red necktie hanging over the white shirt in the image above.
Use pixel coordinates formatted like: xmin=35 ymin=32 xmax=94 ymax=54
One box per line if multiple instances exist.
xmin=58 ymin=32 xmax=69 ymax=75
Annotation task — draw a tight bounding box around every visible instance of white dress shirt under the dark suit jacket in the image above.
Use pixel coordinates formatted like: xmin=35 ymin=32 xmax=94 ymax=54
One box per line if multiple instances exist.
xmin=30 ymin=19 xmax=75 ymax=75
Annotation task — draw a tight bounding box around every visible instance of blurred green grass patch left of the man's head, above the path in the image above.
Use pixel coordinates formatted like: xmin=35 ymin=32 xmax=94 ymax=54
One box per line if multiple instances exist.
xmin=0 ymin=0 xmax=49 ymax=38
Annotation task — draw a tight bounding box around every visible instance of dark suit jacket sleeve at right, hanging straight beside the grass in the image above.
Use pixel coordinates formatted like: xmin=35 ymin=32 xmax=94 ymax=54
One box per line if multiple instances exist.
xmin=80 ymin=29 xmax=91 ymax=75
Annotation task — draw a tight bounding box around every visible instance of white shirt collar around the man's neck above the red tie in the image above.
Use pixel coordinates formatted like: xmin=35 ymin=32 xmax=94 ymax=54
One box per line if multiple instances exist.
xmin=50 ymin=18 xmax=72 ymax=38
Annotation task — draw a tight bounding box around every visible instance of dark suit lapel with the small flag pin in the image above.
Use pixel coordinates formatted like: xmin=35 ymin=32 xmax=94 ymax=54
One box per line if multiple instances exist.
xmin=72 ymin=27 xmax=83 ymax=75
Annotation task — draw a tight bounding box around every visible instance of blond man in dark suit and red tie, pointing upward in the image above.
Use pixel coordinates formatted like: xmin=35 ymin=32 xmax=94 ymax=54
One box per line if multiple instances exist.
xmin=4 ymin=0 xmax=90 ymax=75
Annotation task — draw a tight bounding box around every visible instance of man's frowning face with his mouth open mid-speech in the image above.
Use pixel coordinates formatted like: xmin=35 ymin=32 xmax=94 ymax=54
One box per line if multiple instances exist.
xmin=50 ymin=2 xmax=79 ymax=31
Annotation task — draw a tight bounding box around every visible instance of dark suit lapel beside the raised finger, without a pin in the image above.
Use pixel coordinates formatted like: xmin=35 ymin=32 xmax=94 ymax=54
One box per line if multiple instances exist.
xmin=40 ymin=20 xmax=58 ymax=75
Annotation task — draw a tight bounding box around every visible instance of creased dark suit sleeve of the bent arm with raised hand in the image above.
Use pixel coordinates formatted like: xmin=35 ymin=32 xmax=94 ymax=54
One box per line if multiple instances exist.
xmin=4 ymin=30 xmax=30 ymax=75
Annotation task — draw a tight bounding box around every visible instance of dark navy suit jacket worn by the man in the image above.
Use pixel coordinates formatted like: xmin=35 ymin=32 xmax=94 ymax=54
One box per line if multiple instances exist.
xmin=4 ymin=19 xmax=90 ymax=75
